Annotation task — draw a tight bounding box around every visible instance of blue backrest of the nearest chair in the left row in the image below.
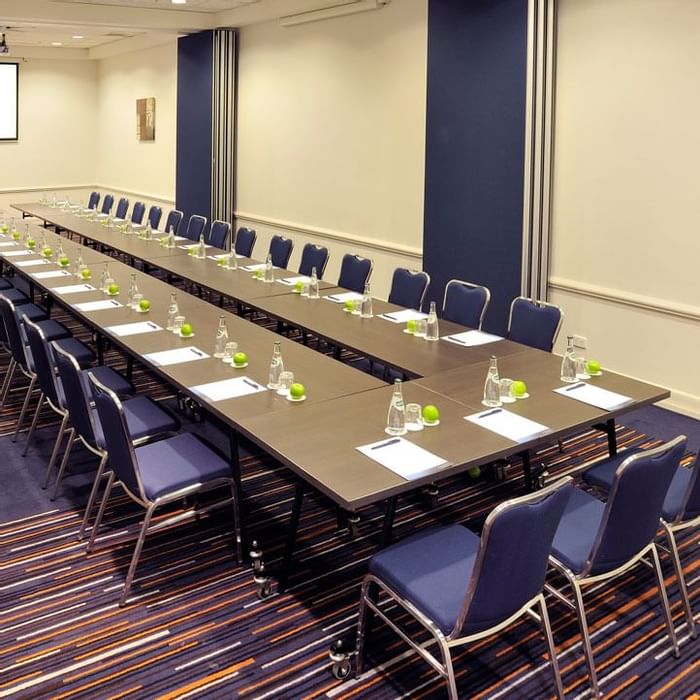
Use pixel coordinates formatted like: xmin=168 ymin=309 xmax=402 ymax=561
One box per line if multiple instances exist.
xmin=88 ymin=372 xmax=148 ymax=501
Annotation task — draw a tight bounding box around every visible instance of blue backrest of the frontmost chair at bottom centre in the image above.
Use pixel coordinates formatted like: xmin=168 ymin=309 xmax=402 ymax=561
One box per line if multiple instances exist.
xmin=450 ymin=477 xmax=573 ymax=637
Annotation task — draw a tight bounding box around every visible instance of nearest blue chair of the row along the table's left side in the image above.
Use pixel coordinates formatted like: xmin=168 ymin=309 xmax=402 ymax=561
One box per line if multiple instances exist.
xmin=87 ymin=374 xmax=241 ymax=606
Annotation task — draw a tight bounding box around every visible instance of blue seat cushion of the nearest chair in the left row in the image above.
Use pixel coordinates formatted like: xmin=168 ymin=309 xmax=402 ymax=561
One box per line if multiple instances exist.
xmin=135 ymin=434 xmax=231 ymax=500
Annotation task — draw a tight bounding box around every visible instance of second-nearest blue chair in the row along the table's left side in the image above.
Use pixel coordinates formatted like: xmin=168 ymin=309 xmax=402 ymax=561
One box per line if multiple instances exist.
xmin=54 ymin=344 xmax=180 ymax=540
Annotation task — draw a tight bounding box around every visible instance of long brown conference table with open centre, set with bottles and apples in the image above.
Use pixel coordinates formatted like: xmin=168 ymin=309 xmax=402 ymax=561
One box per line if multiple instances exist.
xmin=5 ymin=205 xmax=669 ymax=592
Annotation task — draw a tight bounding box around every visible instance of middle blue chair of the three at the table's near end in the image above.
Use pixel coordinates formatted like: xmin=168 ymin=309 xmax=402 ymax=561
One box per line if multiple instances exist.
xmin=546 ymin=435 xmax=687 ymax=697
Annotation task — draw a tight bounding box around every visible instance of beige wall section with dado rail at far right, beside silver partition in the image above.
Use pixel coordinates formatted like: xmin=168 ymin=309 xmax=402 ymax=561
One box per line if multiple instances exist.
xmin=550 ymin=0 xmax=700 ymax=415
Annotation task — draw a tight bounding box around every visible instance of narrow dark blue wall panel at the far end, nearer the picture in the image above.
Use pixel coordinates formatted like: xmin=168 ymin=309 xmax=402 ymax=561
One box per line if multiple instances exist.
xmin=175 ymin=32 xmax=214 ymax=226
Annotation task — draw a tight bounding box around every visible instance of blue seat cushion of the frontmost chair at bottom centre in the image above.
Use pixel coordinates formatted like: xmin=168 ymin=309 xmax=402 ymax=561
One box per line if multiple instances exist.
xmin=369 ymin=525 xmax=481 ymax=634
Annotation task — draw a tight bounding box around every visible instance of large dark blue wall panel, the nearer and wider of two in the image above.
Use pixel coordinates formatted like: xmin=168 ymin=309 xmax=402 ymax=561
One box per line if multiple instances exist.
xmin=423 ymin=0 xmax=528 ymax=333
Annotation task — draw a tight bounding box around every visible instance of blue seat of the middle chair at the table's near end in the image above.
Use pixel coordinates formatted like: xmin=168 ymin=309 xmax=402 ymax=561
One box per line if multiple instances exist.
xmin=552 ymin=489 xmax=605 ymax=574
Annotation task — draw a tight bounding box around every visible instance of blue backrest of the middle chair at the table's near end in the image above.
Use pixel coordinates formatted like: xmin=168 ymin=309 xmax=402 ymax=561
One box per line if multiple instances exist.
xmin=582 ymin=435 xmax=688 ymax=576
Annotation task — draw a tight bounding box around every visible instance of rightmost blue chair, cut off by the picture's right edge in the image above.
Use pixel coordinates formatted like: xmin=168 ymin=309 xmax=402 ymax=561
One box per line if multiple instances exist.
xmin=582 ymin=448 xmax=700 ymax=639
